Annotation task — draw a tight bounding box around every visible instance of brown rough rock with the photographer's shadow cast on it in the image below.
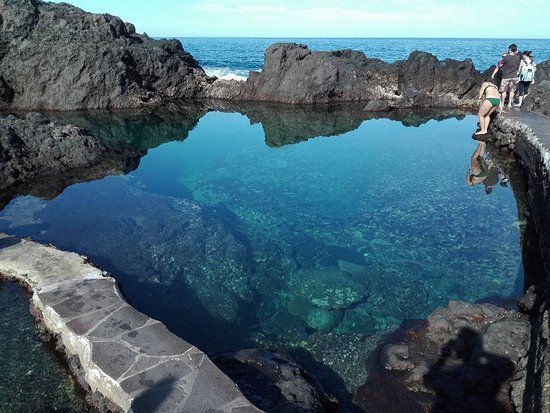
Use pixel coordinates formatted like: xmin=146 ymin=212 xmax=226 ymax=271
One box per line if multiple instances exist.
xmin=355 ymin=301 xmax=530 ymax=413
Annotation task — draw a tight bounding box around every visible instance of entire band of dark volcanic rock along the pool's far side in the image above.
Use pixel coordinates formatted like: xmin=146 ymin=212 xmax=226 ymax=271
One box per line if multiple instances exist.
xmin=0 ymin=0 xmax=550 ymax=111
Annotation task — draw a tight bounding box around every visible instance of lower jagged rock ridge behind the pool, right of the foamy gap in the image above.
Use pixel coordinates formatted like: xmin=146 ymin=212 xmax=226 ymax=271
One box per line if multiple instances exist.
xmin=206 ymin=43 xmax=483 ymax=111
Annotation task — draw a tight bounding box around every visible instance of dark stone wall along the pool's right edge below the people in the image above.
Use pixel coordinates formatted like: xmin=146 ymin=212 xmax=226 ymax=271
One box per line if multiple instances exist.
xmin=491 ymin=112 xmax=550 ymax=412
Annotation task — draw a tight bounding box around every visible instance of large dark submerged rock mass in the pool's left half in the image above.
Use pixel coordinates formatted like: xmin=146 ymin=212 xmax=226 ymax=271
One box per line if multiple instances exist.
xmin=28 ymin=183 xmax=254 ymax=322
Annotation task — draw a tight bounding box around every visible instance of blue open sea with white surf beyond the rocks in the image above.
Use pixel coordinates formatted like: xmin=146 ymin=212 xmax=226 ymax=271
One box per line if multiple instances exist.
xmin=179 ymin=37 xmax=550 ymax=79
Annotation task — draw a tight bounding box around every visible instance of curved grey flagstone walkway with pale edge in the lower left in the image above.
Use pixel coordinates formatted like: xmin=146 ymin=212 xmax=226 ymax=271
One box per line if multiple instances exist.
xmin=0 ymin=234 xmax=261 ymax=413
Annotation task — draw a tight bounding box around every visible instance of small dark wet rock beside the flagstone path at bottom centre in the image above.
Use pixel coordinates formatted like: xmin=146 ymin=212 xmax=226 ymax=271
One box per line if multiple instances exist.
xmin=216 ymin=349 xmax=338 ymax=413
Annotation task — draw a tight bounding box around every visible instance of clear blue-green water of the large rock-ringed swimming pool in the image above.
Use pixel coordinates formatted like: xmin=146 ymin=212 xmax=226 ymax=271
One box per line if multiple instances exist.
xmin=0 ymin=105 xmax=544 ymax=408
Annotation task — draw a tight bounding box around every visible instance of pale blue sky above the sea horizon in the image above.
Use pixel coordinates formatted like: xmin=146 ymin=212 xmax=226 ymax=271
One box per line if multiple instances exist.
xmin=49 ymin=0 xmax=550 ymax=39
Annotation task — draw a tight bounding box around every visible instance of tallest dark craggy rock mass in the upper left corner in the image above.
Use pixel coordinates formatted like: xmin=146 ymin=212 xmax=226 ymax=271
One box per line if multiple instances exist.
xmin=0 ymin=0 xmax=211 ymax=110
